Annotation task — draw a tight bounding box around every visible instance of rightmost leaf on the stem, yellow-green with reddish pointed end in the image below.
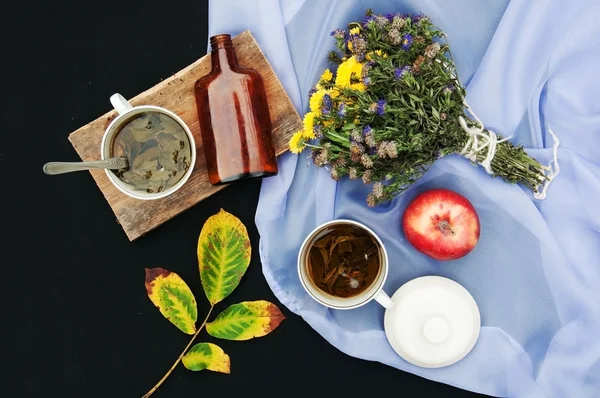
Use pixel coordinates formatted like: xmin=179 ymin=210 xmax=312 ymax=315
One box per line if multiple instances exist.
xmin=206 ymin=300 xmax=285 ymax=340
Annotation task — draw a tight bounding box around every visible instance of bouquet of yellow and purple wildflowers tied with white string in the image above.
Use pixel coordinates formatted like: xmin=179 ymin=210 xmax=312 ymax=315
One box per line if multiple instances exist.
xmin=290 ymin=10 xmax=550 ymax=206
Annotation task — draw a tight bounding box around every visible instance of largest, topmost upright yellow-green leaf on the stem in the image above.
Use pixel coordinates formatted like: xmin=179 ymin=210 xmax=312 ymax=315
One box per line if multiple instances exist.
xmin=198 ymin=209 xmax=251 ymax=305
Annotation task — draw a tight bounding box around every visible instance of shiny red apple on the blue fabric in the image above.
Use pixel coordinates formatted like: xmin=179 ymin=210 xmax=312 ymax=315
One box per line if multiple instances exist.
xmin=402 ymin=189 xmax=479 ymax=260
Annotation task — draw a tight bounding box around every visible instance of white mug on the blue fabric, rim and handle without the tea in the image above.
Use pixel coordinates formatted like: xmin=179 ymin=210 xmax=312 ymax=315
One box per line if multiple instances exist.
xmin=298 ymin=220 xmax=393 ymax=310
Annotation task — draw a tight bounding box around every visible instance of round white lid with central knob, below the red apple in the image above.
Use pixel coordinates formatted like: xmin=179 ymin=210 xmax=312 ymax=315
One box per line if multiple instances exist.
xmin=384 ymin=276 xmax=481 ymax=368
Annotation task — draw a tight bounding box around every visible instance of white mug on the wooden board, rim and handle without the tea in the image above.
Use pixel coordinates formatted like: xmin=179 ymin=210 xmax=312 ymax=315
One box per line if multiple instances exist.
xmin=100 ymin=93 xmax=196 ymax=200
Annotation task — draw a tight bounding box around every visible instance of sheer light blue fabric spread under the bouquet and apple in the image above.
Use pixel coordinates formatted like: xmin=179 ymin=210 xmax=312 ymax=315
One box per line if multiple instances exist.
xmin=210 ymin=0 xmax=600 ymax=397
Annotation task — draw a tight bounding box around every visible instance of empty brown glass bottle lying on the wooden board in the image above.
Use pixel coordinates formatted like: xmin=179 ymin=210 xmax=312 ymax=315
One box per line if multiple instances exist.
xmin=195 ymin=35 xmax=277 ymax=185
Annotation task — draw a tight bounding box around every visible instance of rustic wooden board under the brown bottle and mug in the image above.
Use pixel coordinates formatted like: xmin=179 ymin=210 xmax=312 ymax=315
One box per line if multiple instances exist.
xmin=69 ymin=31 xmax=302 ymax=241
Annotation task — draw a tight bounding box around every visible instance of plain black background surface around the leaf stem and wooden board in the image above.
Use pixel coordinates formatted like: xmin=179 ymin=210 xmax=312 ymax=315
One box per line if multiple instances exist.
xmin=0 ymin=0 xmax=488 ymax=397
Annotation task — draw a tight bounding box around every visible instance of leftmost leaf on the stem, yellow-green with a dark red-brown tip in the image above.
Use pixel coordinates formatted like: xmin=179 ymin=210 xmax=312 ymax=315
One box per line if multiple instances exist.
xmin=146 ymin=268 xmax=198 ymax=334
